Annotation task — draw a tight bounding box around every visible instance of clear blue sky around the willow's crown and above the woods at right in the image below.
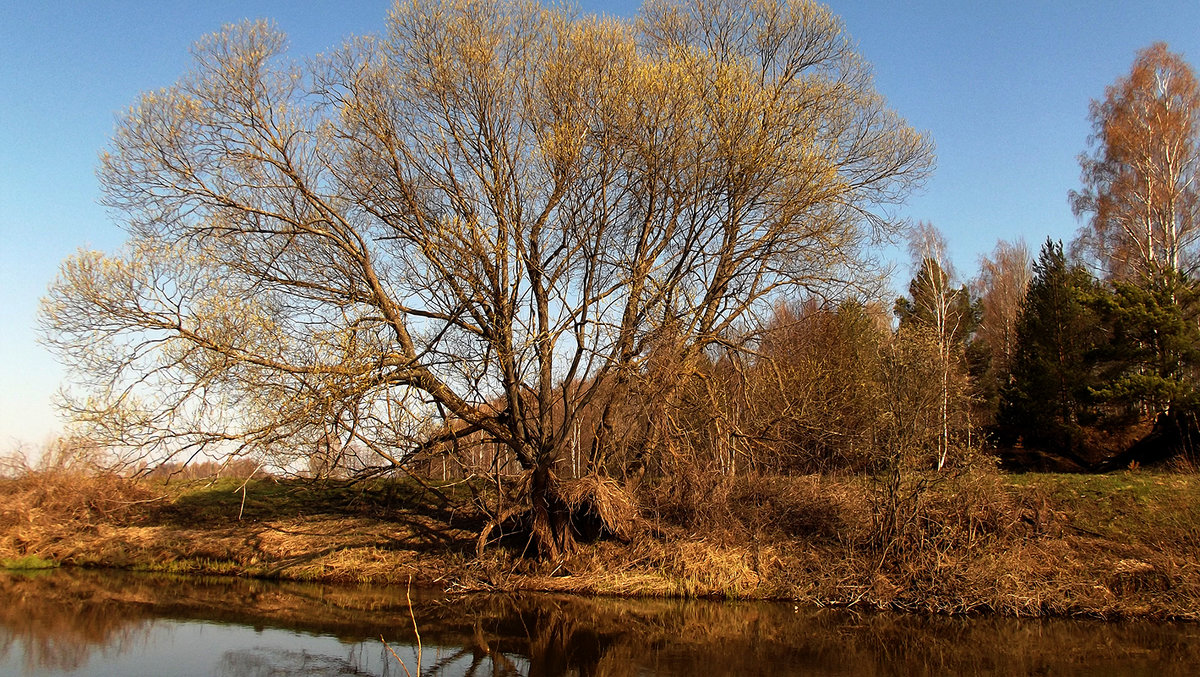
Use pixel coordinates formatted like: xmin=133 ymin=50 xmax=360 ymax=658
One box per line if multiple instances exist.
xmin=0 ymin=0 xmax=1200 ymax=451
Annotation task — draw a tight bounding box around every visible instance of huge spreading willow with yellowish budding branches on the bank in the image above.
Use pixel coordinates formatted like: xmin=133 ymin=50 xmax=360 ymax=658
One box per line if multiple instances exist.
xmin=43 ymin=0 xmax=931 ymax=556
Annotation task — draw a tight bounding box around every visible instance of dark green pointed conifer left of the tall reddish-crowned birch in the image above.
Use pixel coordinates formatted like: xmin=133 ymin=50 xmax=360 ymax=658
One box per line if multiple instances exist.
xmin=997 ymin=239 xmax=1098 ymax=457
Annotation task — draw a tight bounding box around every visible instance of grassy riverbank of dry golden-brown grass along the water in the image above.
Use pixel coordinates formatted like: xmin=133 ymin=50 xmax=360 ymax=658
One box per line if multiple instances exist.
xmin=0 ymin=471 xmax=1200 ymax=621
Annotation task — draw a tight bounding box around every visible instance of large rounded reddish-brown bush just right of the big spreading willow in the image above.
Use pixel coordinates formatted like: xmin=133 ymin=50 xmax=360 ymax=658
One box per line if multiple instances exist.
xmin=682 ymin=300 xmax=886 ymax=473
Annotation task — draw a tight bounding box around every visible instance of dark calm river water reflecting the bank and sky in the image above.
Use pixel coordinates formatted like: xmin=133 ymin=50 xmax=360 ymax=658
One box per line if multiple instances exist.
xmin=0 ymin=570 xmax=1200 ymax=677
